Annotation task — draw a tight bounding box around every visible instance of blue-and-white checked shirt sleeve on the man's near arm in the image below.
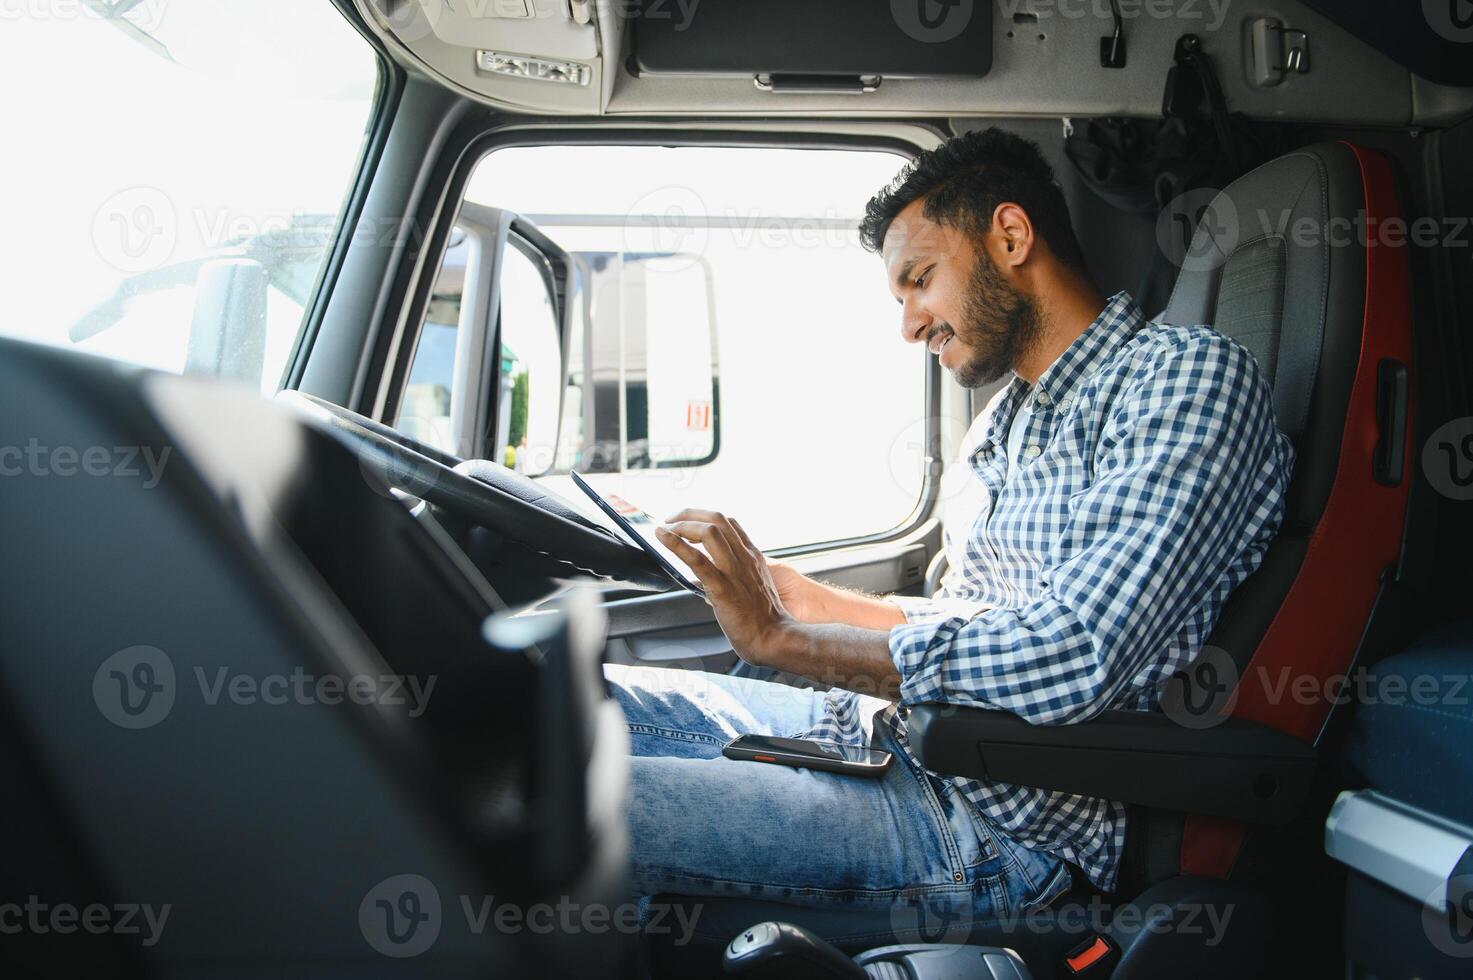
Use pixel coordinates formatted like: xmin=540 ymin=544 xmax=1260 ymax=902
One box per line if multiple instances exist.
xmin=890 ymin=336 xmax=1292 ymax=724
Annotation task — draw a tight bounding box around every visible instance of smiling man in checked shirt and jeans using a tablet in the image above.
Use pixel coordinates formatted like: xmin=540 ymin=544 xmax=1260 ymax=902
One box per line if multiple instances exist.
xmin=607 ymin=130 xmax=1292 ymax=918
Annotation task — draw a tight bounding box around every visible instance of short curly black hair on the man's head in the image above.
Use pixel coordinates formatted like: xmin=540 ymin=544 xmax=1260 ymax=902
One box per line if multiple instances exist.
xmin=859 ymin=128 xmax=1087 ymax=274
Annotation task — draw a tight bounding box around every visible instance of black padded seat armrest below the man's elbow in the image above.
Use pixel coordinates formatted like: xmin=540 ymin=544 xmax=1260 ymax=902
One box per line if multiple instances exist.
xmin=906 ymin=704 xmax=1315 ymax=825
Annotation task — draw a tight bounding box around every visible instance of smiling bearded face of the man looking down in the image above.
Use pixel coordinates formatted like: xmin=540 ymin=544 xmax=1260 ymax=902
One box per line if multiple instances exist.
xmin=879 ymin=199 xmax=1041 ymax=388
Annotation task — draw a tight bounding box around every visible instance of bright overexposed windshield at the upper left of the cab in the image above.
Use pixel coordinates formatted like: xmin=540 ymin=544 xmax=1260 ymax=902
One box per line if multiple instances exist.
xmin=0 ymin=0 xmax=379 ymax=393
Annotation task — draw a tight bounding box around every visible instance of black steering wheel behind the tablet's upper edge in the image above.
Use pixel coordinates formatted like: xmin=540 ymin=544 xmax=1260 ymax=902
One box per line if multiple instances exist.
xmin=277 ymin=391 xmax=672 ymax=589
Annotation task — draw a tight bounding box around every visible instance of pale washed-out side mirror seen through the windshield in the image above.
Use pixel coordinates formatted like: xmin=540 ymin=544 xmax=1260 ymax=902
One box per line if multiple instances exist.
xmin=184 ymin=258 xmax=270 ymax=386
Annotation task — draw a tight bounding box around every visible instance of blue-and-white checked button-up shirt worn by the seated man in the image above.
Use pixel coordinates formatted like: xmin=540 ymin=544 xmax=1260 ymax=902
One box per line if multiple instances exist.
xmin=812 ymin=293 xmax=1293 ymax=890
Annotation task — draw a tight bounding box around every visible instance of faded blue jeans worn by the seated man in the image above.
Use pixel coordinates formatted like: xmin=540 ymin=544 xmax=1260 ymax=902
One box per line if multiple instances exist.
xmin=604 ymin=665 xmax=1069 ymax=942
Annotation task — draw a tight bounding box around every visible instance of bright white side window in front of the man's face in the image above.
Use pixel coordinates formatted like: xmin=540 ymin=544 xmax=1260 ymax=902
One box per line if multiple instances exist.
xmin=467 ymin=146 xmax=927 ymax=550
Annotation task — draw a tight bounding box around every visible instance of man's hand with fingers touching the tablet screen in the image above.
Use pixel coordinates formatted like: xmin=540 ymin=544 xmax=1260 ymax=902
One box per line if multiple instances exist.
xmin=655 ymin=510 xmax=807 ymax=666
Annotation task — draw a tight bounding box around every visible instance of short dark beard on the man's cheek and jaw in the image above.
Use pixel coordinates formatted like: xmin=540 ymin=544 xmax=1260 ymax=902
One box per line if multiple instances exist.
xmin=943 ymin=249 xmax=1043 ymax=388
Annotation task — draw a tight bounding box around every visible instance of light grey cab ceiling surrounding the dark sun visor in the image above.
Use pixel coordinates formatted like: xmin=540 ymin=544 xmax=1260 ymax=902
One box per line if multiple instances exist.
xmin=354 ymin=0 xmax=1473 ymax=127
